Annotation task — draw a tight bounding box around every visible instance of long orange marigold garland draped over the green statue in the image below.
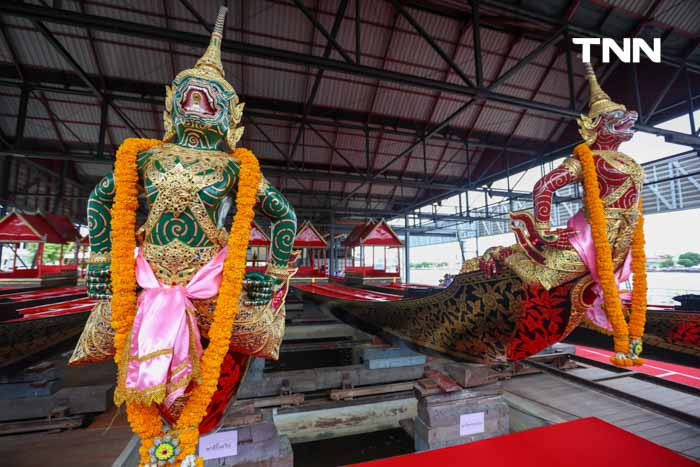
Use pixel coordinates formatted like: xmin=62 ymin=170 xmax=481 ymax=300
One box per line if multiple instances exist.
xmin=112 ymin=138 xmax=261 ymax=467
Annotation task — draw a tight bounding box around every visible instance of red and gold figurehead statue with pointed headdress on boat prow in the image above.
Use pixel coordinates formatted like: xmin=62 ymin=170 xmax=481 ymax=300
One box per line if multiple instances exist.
xmin=480 ymin=64 xmax=644 ymax=314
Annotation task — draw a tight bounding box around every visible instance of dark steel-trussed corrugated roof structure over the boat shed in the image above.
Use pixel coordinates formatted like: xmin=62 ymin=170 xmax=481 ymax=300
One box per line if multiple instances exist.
xmin=0 ymin=0 xmax=700 ymax=234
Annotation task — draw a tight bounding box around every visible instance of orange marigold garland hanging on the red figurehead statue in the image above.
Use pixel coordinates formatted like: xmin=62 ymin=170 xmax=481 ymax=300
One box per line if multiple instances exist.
xmin=574 ymin=144 xmax=647 ymax=366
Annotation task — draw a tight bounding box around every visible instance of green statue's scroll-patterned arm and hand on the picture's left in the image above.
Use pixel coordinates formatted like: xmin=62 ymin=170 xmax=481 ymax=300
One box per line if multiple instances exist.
xmin=86 ymin=173 xmax=115 ymax=299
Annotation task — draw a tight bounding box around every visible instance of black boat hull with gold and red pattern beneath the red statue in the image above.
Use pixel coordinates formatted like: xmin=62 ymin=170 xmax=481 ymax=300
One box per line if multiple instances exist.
xmin=298 ymin=272 xmax=583 ymax=364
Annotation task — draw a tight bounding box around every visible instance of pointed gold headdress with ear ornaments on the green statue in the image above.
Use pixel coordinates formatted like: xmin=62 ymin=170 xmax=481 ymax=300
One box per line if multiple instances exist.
xmin=163 ymin=6 xmax=245 ymax=149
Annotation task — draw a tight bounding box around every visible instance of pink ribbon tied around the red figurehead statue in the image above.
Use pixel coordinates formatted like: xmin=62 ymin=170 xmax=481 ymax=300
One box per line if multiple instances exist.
xmin=567 ymin=211 xmax=632 ymax=331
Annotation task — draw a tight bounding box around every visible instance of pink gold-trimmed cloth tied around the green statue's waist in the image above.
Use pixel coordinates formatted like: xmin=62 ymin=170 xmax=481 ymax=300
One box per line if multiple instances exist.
xmin=126 ymin=248 xmax=227 ymax=407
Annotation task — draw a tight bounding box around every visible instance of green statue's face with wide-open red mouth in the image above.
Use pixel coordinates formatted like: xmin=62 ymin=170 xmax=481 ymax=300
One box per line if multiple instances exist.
xmin=172 ymin=76 xmax=235 ymax=149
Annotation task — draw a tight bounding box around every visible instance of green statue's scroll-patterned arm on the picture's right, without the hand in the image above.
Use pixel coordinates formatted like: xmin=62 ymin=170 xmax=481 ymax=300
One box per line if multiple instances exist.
xmin=258 ymin=178 xmax=297 ymax=275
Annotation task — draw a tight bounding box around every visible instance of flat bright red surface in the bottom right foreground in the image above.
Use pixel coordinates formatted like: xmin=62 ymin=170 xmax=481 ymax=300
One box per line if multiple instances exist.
xmin=348 ymin=418 xmax=698 ymax=467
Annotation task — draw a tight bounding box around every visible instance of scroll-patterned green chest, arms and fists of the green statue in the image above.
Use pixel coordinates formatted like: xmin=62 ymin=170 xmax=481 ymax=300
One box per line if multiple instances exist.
xmin=88 ymin=144 xmax=296 ymax=305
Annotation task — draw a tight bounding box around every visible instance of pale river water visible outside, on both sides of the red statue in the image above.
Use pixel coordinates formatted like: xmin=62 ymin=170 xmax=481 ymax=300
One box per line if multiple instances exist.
xmin=411 ymin=268 xmax=700 ymax=305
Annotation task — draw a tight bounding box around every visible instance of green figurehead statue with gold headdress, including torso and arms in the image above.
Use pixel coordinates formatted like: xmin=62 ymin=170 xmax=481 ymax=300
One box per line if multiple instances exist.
xmin=87 ymin=9 xmax=296 ymax=305
